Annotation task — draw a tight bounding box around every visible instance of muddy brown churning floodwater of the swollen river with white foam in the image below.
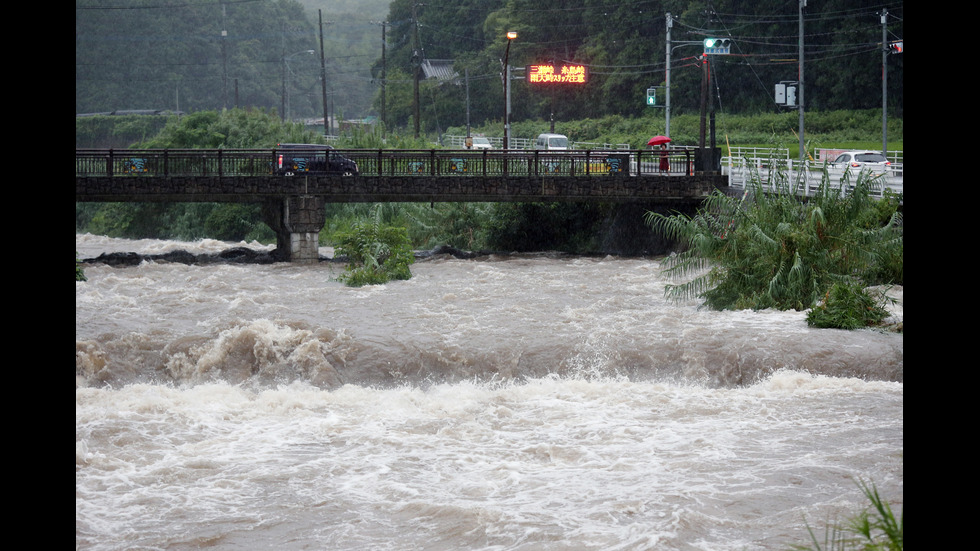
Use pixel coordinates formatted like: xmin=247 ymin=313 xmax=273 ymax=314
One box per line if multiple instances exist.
xmin=75 ymin=235 xmax=904 ymax=551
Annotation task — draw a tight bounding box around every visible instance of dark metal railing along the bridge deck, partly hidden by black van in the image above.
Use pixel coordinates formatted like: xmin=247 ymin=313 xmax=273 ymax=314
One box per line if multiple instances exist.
xmin=75 ymin=149 xmax=694 ymax=177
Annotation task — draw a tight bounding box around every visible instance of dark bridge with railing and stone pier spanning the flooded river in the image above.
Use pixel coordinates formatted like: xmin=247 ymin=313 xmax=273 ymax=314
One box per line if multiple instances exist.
xmin=75 ymin=149 xmax=728 ymax=263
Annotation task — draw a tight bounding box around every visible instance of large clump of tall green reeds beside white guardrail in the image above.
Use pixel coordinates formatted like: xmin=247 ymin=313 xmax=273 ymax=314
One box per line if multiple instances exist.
xmin=647 ymin=173 xmax=903 ymax=328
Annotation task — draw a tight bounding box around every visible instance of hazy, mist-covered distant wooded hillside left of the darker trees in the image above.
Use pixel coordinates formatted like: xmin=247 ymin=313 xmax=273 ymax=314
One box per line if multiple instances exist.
xmin=75 ymin=0 xmax=388 ymax=119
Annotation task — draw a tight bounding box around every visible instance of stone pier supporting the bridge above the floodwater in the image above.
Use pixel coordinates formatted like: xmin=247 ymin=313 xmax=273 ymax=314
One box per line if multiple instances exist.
xmin=262 ymin=195 xmax=327 ymax=264
